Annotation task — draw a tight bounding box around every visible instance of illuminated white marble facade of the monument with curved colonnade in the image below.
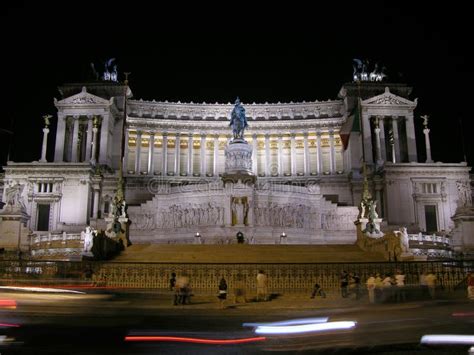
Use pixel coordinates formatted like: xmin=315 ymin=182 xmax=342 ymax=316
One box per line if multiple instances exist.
xmin=3 ymin=83 xmax=472 ymax=249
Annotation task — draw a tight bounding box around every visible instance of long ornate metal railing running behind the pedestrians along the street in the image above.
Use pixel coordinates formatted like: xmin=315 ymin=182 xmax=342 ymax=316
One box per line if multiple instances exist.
xmin=0 ymin=260 xmax=474 ymax=293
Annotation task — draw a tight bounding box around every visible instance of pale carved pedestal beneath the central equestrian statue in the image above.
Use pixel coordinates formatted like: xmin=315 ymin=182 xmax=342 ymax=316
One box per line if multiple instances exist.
xmin=222 ymin=139 xmax=256 ymax=184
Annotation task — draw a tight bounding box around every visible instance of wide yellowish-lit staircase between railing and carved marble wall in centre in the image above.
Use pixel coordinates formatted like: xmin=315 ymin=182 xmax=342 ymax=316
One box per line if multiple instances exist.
xmin=114 ymin=244 xmax=385 ymax=264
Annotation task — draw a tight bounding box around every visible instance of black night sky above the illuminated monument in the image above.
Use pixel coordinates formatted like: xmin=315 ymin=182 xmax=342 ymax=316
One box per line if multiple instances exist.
xmin=0 ymin=0 xmax=474 ymax=170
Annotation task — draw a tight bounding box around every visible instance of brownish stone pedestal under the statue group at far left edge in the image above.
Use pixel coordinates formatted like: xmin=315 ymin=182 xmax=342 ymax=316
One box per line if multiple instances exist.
xmin=0 ymin=206 xmax=31 ymax=252
